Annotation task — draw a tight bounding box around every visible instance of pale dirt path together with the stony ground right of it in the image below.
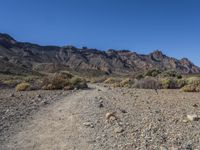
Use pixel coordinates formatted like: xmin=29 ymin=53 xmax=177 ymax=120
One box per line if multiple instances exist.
xmin=0 ymin=85 xmax=200 ymax=150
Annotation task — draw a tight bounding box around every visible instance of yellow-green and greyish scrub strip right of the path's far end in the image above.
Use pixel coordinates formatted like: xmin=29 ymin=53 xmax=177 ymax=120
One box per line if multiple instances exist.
xmin=103 ymin=69 xmax=200 ymax=92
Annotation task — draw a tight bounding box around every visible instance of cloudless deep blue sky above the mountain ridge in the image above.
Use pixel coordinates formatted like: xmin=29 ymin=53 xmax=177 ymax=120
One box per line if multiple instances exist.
xmin=0 ymin=0 xmax=200 ymax=66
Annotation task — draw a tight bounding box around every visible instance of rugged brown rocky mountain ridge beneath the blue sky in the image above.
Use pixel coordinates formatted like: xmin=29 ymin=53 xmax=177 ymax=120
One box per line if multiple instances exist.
xmin=0 ymin=33 xmax=200 ymax=74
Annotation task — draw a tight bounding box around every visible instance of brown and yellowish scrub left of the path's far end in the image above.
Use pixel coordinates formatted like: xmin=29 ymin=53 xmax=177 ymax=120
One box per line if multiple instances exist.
xmin=0 ymin=71 xmax=88 ymax=91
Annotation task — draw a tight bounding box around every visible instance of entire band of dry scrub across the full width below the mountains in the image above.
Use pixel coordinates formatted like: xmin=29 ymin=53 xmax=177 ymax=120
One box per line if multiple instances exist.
xmin=0 ymin=69 xmax=200 ymax=92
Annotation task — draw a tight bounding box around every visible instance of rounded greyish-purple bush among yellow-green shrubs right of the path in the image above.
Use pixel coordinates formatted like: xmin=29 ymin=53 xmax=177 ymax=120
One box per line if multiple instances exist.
xmin=134 ymin=78 xmax=161 ymax=89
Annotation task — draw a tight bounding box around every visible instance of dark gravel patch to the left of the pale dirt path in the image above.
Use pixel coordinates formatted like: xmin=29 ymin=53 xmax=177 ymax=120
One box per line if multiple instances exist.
xmin=0 ymin=89 xmax=74 ymax=144
